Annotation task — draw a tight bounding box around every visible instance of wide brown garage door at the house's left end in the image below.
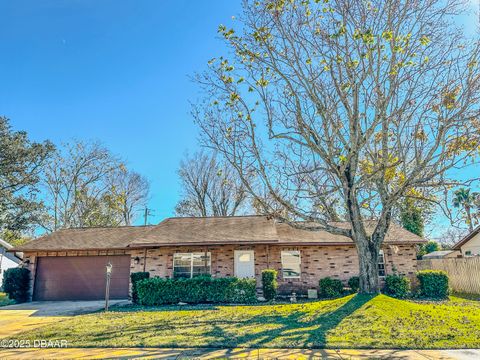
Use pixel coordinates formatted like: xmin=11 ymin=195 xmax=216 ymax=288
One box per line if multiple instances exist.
xmin=33 ymin=255 xmax=130 ymax=301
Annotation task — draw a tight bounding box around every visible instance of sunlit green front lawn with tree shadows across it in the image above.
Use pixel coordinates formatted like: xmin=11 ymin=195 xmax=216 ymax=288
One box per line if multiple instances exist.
xmin=14 ymin=295 xmax=480 ymax=348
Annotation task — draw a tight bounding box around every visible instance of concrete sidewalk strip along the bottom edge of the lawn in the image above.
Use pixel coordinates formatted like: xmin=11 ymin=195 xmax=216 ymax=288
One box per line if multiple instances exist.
xmin=0 ymin=348 xmax=480 ymax=360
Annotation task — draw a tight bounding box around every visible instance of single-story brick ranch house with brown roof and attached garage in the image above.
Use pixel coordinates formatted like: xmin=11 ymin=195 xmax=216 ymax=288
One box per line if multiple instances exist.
xmin=10 ymin=216 xmax=425 ymax=300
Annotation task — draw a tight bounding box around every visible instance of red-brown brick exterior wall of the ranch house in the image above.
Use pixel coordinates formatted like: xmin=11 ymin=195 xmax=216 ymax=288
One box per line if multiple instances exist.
xmin=25 ymin=245 xmax=417 ymax=293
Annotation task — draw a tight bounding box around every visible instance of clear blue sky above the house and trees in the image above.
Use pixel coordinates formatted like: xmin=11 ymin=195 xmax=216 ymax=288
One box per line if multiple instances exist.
xmin=0 ymin=0 xmax=479 ymax=235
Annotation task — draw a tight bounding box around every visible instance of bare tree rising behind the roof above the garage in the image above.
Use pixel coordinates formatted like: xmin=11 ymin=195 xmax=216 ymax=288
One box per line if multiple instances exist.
xmin=41 ymin=141 xmax=149 ymax=231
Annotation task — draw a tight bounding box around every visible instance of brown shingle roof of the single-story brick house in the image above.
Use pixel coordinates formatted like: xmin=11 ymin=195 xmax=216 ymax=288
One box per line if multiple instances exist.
xmin=15 ymin=216 xmax=425 ymax=251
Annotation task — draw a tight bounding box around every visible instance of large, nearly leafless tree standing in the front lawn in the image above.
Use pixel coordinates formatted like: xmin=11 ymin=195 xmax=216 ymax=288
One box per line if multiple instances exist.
xmin=193 ymin=0 xmax=480 ymax=293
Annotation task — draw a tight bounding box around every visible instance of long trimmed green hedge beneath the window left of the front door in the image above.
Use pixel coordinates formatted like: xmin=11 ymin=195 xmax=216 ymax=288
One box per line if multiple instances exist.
xmin=137 ymin=276 xmax=257 ymax=306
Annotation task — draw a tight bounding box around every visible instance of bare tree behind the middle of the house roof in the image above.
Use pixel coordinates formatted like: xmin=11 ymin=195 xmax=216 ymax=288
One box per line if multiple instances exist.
xmin=175 ymin=153 xmax=247 ymax=216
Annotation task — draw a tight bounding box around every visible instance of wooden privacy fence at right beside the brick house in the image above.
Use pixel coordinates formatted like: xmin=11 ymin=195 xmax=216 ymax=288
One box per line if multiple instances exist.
xmin=418 ymin=256 xmax=480 ymax=294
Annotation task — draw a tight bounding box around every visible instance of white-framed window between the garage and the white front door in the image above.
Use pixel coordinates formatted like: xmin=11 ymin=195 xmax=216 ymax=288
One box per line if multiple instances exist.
xmin=173 ymin=252 xmax=211 ymax=278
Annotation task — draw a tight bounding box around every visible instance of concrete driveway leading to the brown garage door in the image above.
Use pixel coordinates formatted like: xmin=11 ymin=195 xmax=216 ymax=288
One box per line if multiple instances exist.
xmin=0 ymin=300 xmax=128 ymax=339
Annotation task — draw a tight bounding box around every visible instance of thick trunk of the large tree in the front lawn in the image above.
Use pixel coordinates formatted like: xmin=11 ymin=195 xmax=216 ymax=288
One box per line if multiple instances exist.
xmin=355 ymin=237 xmax=379 ymax=294
